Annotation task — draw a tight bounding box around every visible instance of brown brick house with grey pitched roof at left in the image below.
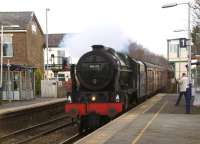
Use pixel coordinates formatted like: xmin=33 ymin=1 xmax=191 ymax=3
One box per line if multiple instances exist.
xmin=0 ymin=12 xmax=44 ymax=100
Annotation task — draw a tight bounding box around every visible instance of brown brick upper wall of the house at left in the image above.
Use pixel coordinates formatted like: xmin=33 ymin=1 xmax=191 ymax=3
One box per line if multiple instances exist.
xmin=0 ymin=19 xmax=44 ymax=69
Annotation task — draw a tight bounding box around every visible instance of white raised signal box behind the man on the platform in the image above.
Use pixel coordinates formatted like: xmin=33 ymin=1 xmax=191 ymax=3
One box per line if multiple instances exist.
xmin=167 ymin=38 xmax=188 ymax=79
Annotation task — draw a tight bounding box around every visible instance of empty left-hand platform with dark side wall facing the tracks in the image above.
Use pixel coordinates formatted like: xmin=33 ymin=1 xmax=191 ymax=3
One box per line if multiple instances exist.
xmin=0 ymin=98 xmax=66 ymax=137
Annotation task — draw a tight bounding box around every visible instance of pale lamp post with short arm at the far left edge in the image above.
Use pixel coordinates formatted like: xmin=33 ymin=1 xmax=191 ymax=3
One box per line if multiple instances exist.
xmin=0 ymin=25 xmax=19 ymax=89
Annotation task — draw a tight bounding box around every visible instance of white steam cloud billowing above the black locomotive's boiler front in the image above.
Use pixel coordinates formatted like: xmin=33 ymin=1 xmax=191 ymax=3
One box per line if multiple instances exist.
xmin=62 ymin=25 xmax=129 ymax=63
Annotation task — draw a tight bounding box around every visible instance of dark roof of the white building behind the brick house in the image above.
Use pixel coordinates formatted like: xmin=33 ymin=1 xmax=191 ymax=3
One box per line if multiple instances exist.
xmin=45 ymin=33 xmax=66 ymax=48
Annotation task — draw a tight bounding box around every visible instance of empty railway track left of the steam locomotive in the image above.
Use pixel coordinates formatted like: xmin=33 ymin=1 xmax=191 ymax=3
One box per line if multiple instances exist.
xmin=0 ymin=116 xmax=74 ymax=144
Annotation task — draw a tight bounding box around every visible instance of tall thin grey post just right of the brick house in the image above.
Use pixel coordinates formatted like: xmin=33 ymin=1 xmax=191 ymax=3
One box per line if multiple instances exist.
xmin=46 ymin=8 xmax=50 ymax=80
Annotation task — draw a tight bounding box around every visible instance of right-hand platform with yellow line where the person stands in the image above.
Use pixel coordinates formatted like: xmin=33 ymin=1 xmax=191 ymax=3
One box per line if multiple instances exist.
xmin=76 ymin=94 xmax=200 ymax=144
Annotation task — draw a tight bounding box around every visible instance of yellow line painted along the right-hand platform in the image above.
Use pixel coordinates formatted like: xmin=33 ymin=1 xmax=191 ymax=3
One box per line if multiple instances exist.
xmin=132 ymin=102 xmax=167 ymax=144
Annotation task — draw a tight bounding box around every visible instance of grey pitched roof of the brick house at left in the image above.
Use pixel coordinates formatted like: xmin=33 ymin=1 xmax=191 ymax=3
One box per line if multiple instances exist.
xmin=0 ymin=11 xmax=43 ymax=33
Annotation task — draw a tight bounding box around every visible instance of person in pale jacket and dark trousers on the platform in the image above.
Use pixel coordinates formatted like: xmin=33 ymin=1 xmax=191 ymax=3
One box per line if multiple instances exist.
xmin=175 ymin=73 xmax=188 ymax=106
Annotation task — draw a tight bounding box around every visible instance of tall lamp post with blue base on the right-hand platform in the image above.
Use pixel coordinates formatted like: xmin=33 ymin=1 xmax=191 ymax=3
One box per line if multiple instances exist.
xmin=162 ymin=2 xmax=192 ymax=113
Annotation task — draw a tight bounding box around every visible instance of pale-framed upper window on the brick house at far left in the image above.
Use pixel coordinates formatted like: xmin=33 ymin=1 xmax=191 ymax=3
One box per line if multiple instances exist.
xmin=0 ymin=34 xmax=13 ymax=57
